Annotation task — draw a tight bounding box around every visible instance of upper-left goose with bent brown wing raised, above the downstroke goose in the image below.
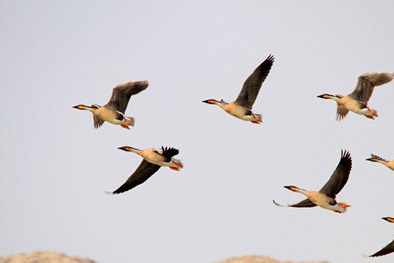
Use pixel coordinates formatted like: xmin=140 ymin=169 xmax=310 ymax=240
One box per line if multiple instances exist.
xmin=73 ymin=81 xmax=148 ymax=129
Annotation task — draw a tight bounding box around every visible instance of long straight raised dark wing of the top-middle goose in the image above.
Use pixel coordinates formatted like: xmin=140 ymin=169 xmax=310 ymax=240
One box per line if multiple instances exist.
xmin=235 ymin=55 xmax=275 ymax=109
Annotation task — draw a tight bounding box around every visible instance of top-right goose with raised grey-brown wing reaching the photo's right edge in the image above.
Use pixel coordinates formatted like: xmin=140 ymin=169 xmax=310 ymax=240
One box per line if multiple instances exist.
xmin=317 ymin=72 xmax=394 ymax=121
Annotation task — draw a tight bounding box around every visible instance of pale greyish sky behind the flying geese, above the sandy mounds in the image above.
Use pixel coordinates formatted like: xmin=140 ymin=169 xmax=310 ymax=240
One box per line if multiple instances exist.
xmin=0 ymin=0 xmax=394 ymax=263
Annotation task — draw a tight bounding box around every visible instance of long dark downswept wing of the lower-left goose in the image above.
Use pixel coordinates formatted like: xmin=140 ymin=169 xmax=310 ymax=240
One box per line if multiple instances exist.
xmin=112 ymin=160 xmax=160 ymax=194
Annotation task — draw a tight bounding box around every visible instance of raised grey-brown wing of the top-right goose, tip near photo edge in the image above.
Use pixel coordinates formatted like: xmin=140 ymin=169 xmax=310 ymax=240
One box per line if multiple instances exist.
xmin=350 ymin=72 xmax=393 ymax=103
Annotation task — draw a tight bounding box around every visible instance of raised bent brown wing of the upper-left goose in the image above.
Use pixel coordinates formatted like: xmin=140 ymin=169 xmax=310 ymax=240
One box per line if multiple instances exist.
xmin=106 ymin=80 xmax=149 ymax=113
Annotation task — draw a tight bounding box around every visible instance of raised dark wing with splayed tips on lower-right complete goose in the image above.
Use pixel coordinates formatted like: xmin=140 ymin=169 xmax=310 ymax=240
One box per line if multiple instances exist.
xmin=319 ymin=151 xmax=352 ymax=199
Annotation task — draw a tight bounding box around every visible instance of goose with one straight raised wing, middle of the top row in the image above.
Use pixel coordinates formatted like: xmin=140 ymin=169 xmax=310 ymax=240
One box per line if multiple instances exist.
xmin=203 ymin=55 xmax=274 ymax=124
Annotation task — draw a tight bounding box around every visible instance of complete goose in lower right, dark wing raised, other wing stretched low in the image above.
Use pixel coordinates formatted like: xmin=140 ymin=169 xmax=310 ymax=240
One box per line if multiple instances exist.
xmin=273 ymin=151 xmax=352 ymax=213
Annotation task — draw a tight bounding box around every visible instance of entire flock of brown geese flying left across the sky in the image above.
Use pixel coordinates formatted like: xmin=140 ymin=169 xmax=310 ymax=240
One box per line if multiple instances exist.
xmin=73 ymin=55 xmax=394 ymax=257
